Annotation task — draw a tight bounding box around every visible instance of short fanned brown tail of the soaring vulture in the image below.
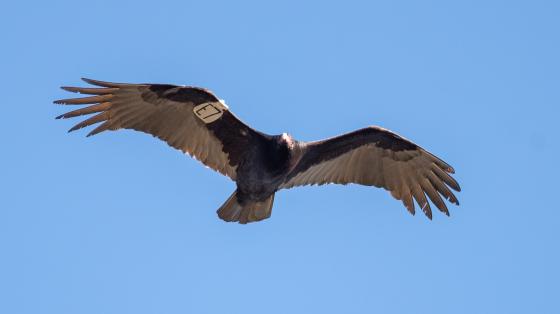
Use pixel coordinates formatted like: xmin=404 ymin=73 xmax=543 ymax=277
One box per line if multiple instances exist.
xmin=218 ymin=191 xmax=274 ymax=224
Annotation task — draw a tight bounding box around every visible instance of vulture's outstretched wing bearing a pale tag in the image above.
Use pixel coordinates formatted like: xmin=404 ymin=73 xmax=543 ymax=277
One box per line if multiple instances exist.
xmin=55 ymin=79 xmax=261 ymax=180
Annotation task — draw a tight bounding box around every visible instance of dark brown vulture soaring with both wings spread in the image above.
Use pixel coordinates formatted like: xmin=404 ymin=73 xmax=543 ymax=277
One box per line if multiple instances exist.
xmin=54 ymin=78 xmax=461 ymax=224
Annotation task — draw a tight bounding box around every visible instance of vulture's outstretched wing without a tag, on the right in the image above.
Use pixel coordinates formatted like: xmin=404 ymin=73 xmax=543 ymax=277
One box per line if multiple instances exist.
xmin=280 ymin=127 xmax=461 ymax=219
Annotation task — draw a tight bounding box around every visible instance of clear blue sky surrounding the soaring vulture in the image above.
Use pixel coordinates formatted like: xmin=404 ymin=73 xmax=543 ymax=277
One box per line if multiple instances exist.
xmin=0 ymin=1 xmax=560 ymax=314
